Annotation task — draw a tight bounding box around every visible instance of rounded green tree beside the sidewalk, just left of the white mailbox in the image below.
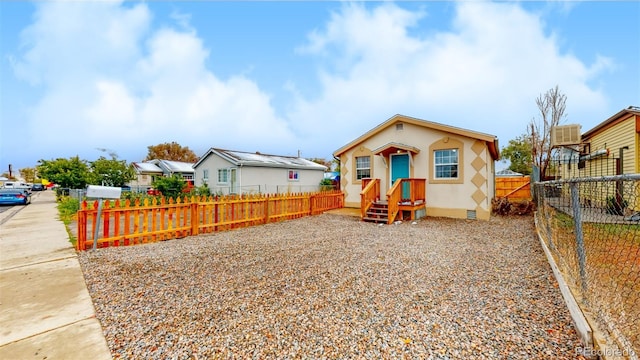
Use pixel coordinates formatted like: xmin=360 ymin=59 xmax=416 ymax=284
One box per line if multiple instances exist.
xmin=36 ymin=156 xmax=89 ymax=189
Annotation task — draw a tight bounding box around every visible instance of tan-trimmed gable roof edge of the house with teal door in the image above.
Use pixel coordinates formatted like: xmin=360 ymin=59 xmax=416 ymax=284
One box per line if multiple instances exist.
xmin=333 ymin=114 xmax=500 ymax=160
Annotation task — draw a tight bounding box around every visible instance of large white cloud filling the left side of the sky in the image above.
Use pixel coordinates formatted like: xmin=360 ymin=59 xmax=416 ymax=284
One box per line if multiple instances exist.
xmin=15 ymin=2 xmax=296 ymax=161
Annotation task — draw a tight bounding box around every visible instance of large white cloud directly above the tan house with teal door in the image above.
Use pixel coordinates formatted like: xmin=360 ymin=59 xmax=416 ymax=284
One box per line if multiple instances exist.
xmin=289 ymin=2 xmax=610 ymax=155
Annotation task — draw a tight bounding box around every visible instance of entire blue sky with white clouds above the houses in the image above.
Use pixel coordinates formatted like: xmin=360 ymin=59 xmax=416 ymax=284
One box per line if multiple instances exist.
xmin=0 ymin=1 xmax=640 ymax=172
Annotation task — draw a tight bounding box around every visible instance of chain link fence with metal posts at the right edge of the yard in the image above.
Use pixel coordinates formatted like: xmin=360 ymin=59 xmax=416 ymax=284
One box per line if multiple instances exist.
xmin=534 ymin=174 xmax=640 ymax=359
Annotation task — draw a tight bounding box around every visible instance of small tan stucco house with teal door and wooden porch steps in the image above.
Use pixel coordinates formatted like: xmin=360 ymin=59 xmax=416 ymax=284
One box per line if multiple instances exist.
xmin=333 ymin=115 xmax=500 ymax=222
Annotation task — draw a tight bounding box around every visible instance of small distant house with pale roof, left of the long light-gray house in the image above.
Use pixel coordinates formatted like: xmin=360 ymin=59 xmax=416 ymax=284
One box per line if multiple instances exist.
xmin=129 ymin=159 xmax=194 ymax=191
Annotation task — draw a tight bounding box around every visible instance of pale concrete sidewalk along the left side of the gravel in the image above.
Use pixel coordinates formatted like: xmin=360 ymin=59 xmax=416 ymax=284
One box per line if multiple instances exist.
xmin=0 ymin=190 xmax=112 ymax=360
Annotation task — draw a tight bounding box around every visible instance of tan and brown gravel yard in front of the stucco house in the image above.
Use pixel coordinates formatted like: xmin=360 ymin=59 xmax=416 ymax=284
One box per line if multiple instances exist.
xmin=79 ymin=214 xmax=580 ymax=359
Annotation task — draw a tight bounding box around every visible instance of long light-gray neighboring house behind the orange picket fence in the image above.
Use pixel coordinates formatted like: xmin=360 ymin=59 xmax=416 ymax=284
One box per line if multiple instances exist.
xmin=193 ymin=148 xmax=327 ymax=194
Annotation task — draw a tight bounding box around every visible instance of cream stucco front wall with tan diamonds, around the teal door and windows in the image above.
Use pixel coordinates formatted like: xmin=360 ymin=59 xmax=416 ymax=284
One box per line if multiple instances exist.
xmin=340 ymin=123 xmax=495 ymax=220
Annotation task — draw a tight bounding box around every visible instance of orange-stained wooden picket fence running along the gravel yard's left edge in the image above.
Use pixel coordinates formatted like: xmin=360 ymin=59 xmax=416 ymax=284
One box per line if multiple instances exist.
xmin=77 ymin=190 xmax=344 ymax=250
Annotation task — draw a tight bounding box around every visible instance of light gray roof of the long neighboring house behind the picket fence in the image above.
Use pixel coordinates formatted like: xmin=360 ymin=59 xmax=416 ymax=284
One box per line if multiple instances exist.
xmin=193 ymin=148 xmax=327 ymax=171
